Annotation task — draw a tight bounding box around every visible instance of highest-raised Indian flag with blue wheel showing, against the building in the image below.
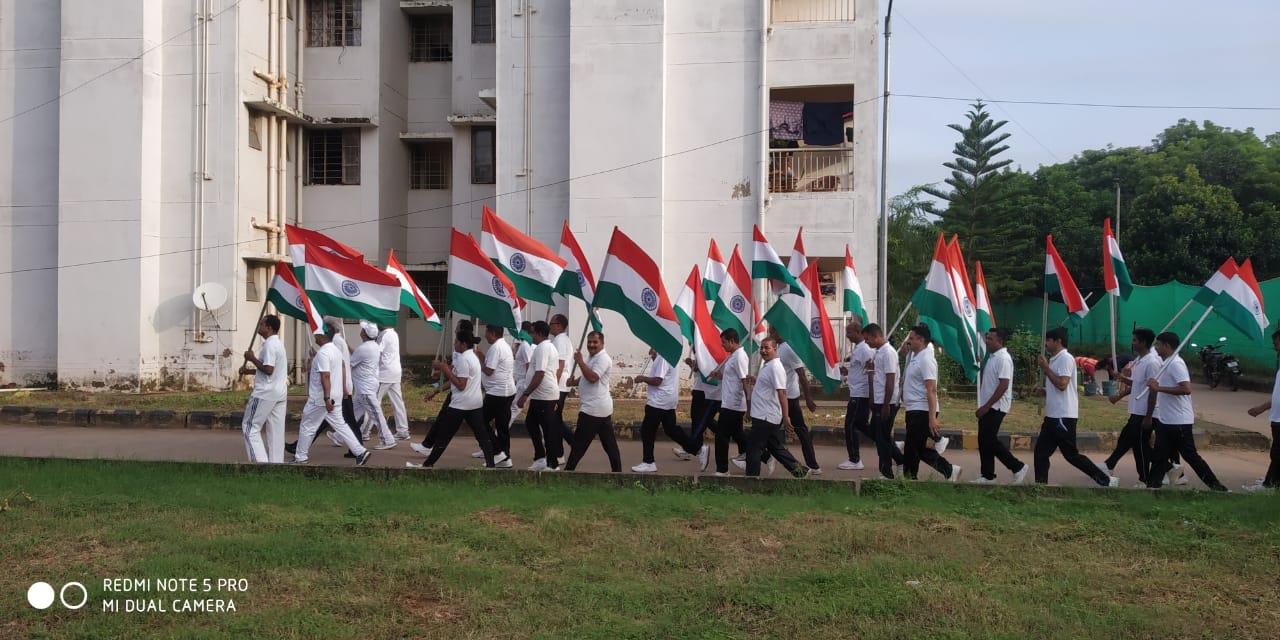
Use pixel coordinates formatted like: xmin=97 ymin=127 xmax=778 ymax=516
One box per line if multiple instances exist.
xmin=480 ymin=207 xmax=566 ymax=305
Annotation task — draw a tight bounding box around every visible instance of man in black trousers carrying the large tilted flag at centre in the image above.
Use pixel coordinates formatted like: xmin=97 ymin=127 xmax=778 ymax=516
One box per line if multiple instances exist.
xmin=564 ymin=332 xmax=622 ymax=474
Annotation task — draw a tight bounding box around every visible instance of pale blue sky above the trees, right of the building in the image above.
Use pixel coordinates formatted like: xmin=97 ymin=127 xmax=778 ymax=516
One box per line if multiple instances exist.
xmin=879 ymin=0 xmax=1280 ymax=196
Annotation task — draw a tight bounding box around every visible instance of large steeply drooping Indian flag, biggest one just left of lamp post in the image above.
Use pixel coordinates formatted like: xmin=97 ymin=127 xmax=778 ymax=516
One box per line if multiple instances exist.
xmin=764 ymin=262 xmax=840 ymax=392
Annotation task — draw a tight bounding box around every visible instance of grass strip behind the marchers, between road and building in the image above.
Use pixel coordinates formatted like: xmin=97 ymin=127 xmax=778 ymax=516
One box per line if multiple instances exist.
xmin=0 ymin=384 xmax=1128 ymax=433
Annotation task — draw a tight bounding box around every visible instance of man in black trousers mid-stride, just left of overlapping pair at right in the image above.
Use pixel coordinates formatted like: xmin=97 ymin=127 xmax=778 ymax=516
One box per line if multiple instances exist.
xmin=1036 ymin=326 xmax=1120 ymax=486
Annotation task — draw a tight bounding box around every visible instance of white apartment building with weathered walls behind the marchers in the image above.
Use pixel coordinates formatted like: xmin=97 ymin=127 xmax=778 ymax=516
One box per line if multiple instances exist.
xmin=0 ymin=0 xmax=879 ymax=389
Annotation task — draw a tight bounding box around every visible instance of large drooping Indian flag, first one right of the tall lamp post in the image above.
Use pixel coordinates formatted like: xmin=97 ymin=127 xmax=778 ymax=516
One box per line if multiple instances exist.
xmin=911 ymin=238 xmax=978 ymax=380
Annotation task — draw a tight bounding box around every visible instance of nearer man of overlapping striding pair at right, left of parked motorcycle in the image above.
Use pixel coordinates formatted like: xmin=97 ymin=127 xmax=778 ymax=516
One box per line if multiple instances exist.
xmin=1144 ymin=332 xmax=1228 ymax=492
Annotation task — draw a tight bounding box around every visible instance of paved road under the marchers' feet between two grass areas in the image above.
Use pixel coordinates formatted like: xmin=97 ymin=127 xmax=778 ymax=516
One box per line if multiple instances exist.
xmin=0 ymin=425 xmax=1267 ymax=490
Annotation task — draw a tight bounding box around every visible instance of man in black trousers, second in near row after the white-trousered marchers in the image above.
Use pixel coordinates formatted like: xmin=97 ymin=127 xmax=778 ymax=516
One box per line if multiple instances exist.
xmin=516 ymin=320 xmax=564 ymax=471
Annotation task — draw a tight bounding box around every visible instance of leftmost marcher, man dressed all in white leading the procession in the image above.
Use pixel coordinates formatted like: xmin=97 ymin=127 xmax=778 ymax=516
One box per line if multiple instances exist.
xmin=239 ymin=314 xmax=289 ymax=463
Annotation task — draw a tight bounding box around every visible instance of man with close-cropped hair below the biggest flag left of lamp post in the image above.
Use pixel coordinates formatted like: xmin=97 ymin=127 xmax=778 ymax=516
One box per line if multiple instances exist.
xmin=746 ymin=338 xmax=809 ymax=477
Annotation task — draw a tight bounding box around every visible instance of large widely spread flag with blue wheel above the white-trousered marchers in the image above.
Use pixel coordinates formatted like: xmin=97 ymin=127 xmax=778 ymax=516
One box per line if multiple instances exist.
xmin=303 ymin=244 xmax=401 ymax=325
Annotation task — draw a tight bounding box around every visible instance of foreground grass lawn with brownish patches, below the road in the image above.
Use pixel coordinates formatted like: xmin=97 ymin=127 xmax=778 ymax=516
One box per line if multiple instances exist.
xmin=0 ymin=458 xmax=1280 ymax=640
